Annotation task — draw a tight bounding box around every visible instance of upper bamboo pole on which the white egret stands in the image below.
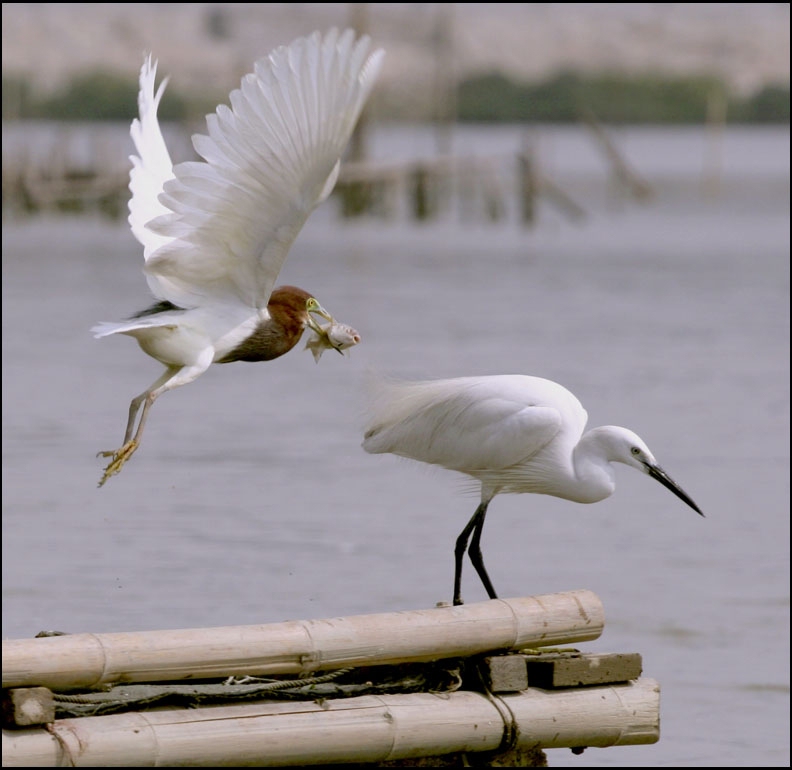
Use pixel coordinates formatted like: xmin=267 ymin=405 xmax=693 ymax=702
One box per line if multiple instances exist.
xmin=2 ymin=590 xmax=605 ymax=690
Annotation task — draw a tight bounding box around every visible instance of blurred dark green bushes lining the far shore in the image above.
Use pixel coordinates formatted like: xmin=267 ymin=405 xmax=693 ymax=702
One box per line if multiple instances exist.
xmin=2 ymin=72 xmax=790 ymax=124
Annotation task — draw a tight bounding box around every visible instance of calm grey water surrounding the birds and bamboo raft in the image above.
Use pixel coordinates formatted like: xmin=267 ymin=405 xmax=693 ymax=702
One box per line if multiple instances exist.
xmin=3 ymin=130 xmax=790 ymax=767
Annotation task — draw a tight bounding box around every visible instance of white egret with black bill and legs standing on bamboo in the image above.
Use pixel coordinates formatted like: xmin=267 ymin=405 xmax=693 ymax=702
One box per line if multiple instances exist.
xmin=363 ymin=374 xmax=704 ymax=604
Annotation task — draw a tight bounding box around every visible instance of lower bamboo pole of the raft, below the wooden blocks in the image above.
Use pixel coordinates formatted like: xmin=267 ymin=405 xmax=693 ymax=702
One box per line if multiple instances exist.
xmin=3 ymin=679 xmax=660 ymax=767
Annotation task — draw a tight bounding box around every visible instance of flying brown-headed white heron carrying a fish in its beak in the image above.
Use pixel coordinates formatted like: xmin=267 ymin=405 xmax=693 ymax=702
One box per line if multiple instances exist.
xmin=92 ymin=29 xmax=384 ymax=486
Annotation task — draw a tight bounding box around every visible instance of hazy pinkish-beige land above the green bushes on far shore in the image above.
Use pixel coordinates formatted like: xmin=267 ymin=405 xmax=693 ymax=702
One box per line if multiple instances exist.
xmin=2 ymin=3 xmax=790 ymax=105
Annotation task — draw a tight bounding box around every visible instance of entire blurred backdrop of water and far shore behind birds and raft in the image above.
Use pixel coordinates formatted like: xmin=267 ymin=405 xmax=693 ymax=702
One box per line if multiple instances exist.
xmin=2 ymin=3 xmax=790 ymax=767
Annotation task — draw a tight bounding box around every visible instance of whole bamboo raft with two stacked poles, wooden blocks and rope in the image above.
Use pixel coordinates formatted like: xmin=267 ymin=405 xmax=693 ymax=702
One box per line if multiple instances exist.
xmin=2 ymin=590 xmax=659 ymax=767
